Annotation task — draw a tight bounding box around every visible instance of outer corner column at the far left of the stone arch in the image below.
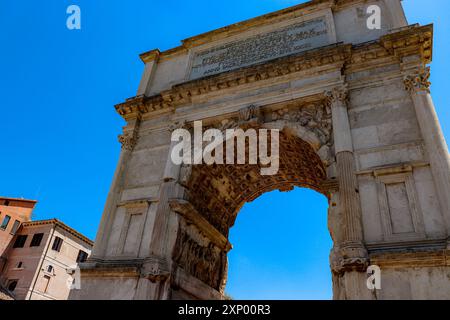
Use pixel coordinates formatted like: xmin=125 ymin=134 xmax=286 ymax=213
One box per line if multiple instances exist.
xmin=90 ymin=118 xmax=140 ymax=260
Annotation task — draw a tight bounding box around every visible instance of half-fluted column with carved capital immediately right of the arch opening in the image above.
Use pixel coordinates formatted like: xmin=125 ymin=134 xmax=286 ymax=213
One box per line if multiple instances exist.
xmin=325 ymin=86 xmax=367 ymax=271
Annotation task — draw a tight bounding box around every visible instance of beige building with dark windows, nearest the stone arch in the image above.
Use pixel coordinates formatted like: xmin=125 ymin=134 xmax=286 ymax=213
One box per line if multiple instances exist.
xmin=0 ymin=219 xmax=93 ymax=300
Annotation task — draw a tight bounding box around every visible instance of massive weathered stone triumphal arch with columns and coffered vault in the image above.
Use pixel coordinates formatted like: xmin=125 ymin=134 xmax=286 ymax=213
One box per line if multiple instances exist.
xmin=71 ymin=0 xmax=450 ymax=299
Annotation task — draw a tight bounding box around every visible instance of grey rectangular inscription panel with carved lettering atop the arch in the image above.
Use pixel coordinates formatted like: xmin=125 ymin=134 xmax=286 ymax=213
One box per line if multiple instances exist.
xmin=189 ymin=17 xmax=330 ymax=79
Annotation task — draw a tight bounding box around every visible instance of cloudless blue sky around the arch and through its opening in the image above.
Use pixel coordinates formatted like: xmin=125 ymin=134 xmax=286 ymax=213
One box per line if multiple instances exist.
xmin=0 ymin=0 xmax=450 ymax=299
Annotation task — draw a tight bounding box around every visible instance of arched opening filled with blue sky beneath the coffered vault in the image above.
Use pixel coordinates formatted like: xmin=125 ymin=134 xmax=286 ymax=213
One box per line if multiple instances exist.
xmin=225 ymin=187 xmax=333 ymax=300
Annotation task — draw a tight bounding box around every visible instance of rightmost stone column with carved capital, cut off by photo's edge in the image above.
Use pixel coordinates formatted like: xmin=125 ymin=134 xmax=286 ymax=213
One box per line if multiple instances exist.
xmin=404 ymin=67 xmax=450 ymax=244
